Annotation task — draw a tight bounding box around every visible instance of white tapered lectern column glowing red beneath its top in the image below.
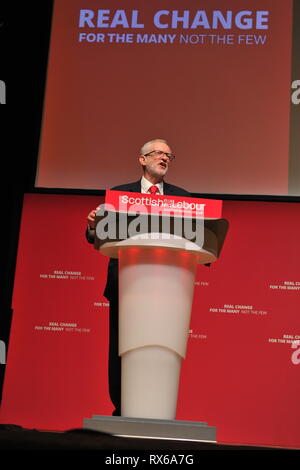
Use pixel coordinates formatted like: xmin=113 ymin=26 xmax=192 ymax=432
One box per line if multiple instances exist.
xmin=86 ymin=191 xmax=228 ymax=440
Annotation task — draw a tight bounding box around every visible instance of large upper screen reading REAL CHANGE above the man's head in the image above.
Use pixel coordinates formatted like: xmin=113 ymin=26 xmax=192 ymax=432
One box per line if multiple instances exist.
xmin=36 ymin=0 xmax=292 ymax=195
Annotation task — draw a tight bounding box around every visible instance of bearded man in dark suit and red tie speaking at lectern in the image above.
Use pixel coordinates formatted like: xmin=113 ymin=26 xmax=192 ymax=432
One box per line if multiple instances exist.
xmin=86 ymin=139 xmax=191 ymax=416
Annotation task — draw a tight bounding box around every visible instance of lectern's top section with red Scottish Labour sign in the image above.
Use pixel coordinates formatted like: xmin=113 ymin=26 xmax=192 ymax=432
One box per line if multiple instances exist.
xmin=94 ymin=191 xmax=228 ymax=264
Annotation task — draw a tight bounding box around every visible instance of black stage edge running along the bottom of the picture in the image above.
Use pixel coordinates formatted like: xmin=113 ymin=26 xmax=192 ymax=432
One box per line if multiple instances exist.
xmin=0 ymin=424 xmax=299 ymax=452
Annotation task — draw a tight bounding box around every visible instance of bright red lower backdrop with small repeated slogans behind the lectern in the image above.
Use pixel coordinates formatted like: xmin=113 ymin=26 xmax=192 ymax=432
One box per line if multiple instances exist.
xmin=0 ymin=194 xmax=300 ymax=447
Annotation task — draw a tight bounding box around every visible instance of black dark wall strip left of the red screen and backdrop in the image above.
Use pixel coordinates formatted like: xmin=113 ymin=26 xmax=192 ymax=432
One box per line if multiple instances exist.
xmin=0 ymin=0 xmax=53 ymax=400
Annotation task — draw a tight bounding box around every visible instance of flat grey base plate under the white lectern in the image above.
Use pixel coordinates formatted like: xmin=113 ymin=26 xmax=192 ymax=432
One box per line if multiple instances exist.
xmin=83 ymin=415 xmax=216 ymax=442
